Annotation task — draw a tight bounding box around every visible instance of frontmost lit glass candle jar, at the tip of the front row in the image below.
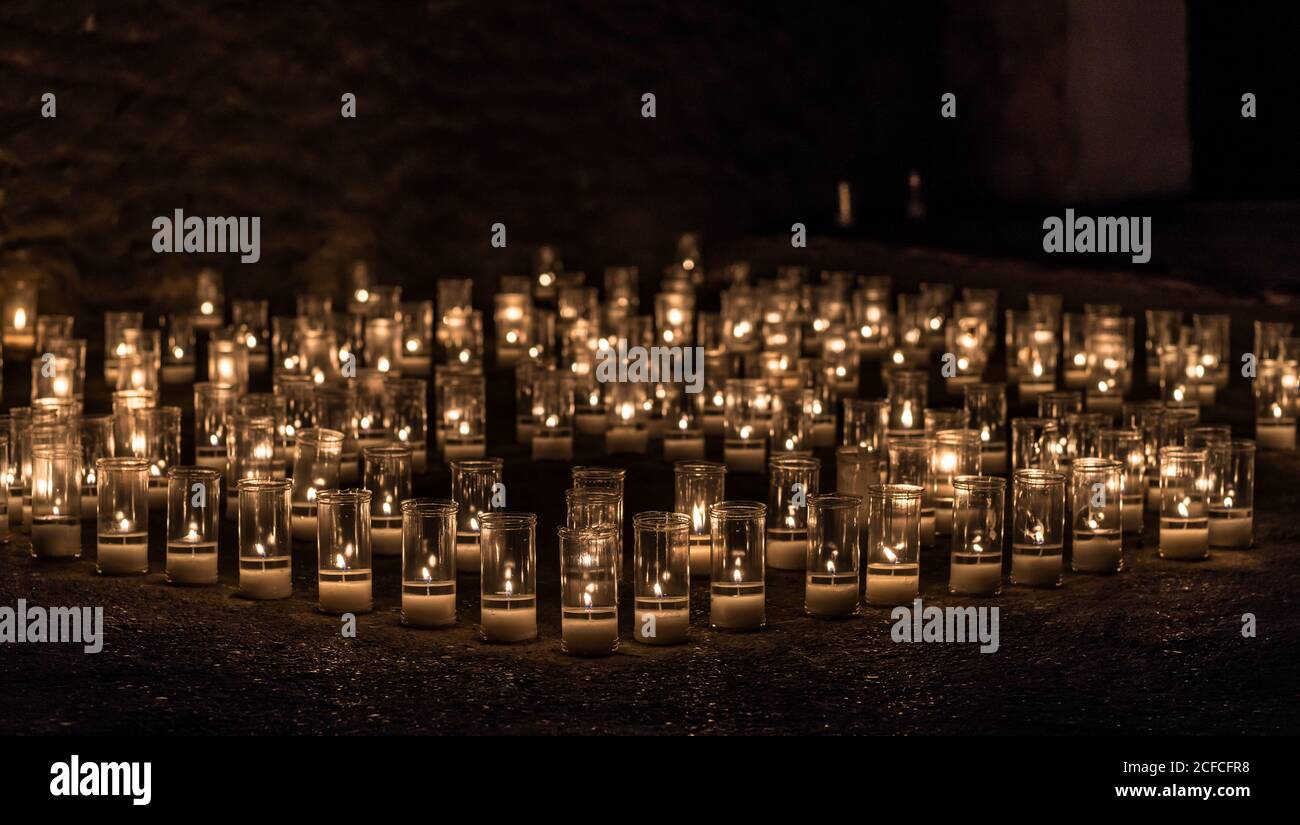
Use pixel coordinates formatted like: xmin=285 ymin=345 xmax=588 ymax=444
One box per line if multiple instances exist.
xmin=558 ymin=524 xmax=619 ymax=656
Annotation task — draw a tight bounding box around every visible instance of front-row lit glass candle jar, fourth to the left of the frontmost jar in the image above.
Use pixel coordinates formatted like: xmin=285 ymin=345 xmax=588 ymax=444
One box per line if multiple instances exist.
xmin=237 ymin=478 xmax=294 ymax=599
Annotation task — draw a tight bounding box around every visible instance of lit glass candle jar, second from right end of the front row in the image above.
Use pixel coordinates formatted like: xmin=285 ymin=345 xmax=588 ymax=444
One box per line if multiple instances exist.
xmin=1160 ymin=447 xmax=1212 ymax=560
